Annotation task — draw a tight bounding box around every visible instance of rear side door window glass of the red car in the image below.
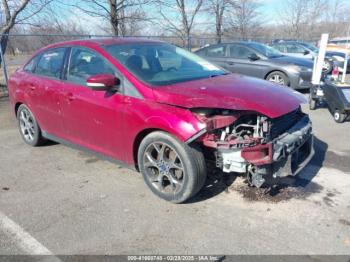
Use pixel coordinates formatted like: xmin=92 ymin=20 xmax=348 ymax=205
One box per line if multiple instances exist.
xmin=34 ymin=48 xmax=66 ymax=78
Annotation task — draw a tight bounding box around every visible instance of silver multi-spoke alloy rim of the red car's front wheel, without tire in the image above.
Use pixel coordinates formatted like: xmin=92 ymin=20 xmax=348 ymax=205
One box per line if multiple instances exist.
xmin=143 ymin=142 xmax=185 ymax=194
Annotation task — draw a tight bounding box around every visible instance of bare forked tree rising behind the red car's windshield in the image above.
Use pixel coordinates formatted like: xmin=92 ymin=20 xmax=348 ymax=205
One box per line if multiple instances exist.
xmin=157 ymin=0 xmax=203 ymax=46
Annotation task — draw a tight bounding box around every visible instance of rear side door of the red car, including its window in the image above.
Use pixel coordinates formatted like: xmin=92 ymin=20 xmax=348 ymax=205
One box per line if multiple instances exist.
xmin=27 ymin=47 xmax=67 ymax=135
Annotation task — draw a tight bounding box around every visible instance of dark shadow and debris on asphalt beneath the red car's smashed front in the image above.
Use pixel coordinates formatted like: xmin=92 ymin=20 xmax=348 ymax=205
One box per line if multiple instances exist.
xmin=188 ymin=137 xmax=328 ymax=203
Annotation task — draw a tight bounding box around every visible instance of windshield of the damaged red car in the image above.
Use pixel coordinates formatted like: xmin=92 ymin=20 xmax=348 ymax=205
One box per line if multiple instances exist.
xmin=104 ymin=43 xmax=226 ymax=86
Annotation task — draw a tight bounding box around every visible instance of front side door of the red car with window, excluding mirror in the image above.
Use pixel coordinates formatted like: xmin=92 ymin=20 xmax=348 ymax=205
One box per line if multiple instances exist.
xmin=60 ymin=47 xmax=123 ymax=159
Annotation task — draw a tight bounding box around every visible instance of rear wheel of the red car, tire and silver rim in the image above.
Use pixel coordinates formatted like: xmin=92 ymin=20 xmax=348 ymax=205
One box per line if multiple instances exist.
xmin=17 ymin=104 xmax=45 ymax=146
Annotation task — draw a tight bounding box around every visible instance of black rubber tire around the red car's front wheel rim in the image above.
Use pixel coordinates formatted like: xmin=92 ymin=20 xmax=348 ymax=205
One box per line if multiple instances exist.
xmin=138 ymin=132 xmax=201 ymax=203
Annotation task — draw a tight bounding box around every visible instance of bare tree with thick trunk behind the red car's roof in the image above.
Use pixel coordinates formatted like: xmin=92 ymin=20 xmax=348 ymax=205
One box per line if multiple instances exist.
xmin=69 ymin=0 xmax=152 ymax=36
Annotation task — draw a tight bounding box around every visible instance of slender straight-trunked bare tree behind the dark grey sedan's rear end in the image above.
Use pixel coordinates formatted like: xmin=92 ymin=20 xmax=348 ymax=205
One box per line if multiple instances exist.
xmin=207 ymin=0 xmax=234 ymax=43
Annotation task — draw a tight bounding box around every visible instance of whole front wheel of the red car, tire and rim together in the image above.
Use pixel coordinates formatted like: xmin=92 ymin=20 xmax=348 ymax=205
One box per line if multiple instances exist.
xmin=138 ymin=131 xmax=206 ymax=203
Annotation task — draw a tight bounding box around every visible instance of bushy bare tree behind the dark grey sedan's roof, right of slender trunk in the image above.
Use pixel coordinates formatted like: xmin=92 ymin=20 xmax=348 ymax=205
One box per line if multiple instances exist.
xmin=230 ymin=0 xmax=262 ymax=40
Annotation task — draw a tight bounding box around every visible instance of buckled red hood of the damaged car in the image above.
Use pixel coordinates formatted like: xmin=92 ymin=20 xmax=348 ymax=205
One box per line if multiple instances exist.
xmin=153 ymin=74 xmax=307 ymax=118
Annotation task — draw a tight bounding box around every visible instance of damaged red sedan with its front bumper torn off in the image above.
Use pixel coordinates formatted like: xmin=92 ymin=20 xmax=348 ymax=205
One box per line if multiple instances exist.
xmin=9 ymin=38 xmax=313 ymax=203
